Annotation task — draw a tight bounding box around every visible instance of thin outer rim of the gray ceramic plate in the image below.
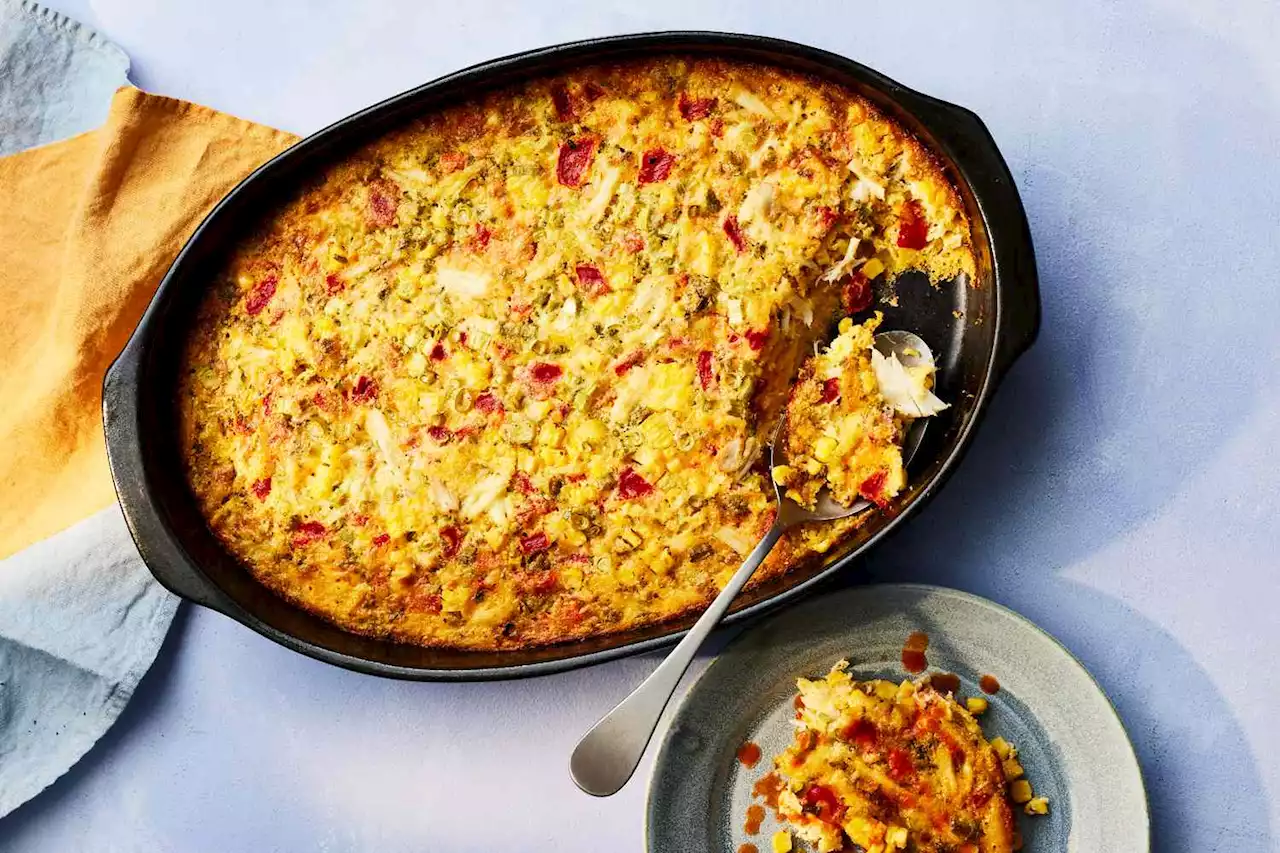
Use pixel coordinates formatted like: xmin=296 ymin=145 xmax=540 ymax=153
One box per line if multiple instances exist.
xmin=644 ymin=581 xmax=1151 ymax=853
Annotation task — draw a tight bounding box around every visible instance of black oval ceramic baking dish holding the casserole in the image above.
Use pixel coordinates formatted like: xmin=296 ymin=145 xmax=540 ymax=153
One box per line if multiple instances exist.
xmin=102 ymin=32 xmax=1039 ymax=680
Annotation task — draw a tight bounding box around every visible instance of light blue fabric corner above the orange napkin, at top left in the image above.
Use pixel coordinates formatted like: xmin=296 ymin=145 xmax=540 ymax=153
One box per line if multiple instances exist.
xmin=0 ymin=0 xmax=129 ymax=155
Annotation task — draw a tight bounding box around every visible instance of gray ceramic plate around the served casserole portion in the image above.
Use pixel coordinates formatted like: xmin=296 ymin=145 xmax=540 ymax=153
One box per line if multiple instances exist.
xmin=645 ymin=584 xmax=1149 ymax=853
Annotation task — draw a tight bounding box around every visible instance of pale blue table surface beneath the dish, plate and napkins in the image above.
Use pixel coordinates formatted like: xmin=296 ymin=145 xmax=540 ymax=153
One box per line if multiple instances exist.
xmin=0 ymin=0 xmax=1280 ymax=853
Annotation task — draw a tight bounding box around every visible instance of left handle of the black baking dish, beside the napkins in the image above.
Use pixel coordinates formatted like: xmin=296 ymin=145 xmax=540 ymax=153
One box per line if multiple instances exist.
xmin=102 ymin=338 xmax=230 ymax=613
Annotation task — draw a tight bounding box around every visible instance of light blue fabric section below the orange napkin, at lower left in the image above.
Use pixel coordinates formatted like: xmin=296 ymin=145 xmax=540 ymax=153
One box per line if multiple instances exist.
xmin=0 ymin=507 xmax=178 ymax=814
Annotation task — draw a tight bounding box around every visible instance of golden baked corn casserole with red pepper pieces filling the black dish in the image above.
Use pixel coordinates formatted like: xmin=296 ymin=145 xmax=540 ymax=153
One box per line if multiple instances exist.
xmin=178 ymin=56 xmax=974 ymax=648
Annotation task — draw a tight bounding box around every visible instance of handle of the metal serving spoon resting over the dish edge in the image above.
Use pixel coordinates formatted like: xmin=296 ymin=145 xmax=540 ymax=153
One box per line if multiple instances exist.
xmin=568 ymin=512 xmax=790 ymax=797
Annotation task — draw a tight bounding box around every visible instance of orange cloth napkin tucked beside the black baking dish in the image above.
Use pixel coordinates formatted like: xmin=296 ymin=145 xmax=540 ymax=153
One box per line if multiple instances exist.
xmin=0 ymin=87 xmax=298 ymax=558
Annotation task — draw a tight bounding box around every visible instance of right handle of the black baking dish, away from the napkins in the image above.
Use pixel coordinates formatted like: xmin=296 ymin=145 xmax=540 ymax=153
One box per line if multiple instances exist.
xmin=910 ymin=92 xmax=1041 ymax=379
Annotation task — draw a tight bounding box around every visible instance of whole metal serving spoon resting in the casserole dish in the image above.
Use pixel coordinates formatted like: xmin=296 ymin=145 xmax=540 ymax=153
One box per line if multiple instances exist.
xmin=568 ymin=332 xmax=933 ymax=797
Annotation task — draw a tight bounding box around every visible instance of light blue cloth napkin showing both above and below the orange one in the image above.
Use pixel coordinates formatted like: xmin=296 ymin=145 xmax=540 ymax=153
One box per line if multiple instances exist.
xmin=0 ymin=0 xmax=178 ymax=819
